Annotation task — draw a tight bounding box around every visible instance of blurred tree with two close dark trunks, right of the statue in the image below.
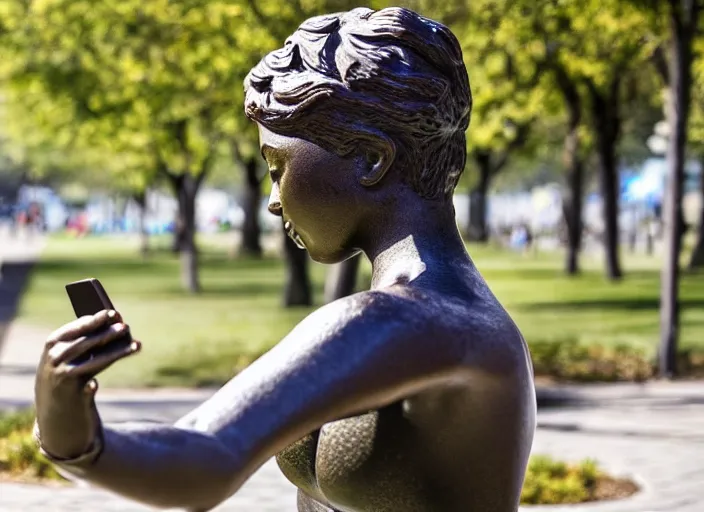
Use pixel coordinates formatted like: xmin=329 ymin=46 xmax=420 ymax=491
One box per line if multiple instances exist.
xmin=470 ymin=0 xmax=654 ymax=279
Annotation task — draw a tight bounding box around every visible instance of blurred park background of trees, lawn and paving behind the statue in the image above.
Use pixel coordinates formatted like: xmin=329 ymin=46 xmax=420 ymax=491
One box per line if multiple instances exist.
xmin=0 ymin=0 xmax=704 ymax=511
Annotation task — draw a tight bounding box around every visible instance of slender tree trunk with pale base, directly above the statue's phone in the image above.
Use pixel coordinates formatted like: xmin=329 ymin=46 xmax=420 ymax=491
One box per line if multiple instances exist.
xmin=170 ymin=173 xmax=200 ymax=293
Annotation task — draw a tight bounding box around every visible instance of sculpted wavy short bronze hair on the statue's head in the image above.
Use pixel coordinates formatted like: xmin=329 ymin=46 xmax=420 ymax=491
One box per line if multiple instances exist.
xmin=245 ymin=8 xmax=472 ymax=199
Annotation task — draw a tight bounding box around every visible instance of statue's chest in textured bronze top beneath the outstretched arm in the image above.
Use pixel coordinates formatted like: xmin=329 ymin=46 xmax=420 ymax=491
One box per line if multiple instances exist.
xmin=277 ymin=404 xmax=425 ymax=512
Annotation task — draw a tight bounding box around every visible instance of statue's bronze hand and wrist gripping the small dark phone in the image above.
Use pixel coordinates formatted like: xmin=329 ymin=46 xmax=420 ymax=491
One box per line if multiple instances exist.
xmin=34 ymin=311 xmax=140 ymax=459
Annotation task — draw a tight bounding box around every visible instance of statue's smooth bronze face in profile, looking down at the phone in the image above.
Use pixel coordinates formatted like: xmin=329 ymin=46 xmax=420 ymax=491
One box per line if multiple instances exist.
xmin=259 ymin=125 xmax=370 ymax=263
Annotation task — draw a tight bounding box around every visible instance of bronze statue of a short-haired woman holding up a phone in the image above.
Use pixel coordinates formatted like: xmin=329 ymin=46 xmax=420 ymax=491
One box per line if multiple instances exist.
xmin=36 ymin=8 xmax=536 ymax=512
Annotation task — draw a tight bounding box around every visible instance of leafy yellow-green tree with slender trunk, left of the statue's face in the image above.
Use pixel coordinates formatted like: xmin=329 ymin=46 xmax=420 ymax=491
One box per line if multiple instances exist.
xmin=3 ymin=0 xmax=291 ymax=292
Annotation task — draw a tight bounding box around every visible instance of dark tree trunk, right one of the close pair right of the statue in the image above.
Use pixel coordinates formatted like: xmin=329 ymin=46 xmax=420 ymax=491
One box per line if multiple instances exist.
xmin=590 ymin=77 xmax=623 ymax=281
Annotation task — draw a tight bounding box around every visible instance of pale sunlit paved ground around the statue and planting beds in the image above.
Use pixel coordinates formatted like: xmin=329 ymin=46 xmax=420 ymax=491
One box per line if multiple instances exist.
xmin=0 ymin=234 xmax=704 ymax=512
